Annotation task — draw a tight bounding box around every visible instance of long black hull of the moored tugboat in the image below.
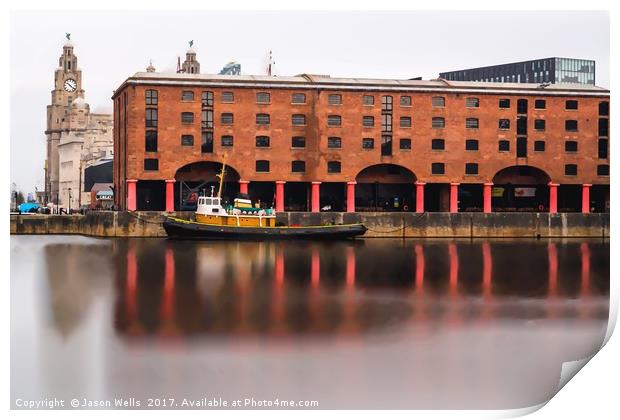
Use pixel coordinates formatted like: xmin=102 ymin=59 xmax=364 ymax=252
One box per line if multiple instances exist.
xmin=164 ymin=217 xmax=367 ymax=240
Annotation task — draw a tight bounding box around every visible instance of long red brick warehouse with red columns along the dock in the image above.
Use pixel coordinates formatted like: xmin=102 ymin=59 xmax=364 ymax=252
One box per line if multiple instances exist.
xmin=113 ymin=51 xmax=609 ymax=212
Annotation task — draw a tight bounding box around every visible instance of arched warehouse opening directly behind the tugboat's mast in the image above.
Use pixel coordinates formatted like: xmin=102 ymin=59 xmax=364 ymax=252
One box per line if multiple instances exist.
xmin=174 ymin=162 xmax=240 ymax=211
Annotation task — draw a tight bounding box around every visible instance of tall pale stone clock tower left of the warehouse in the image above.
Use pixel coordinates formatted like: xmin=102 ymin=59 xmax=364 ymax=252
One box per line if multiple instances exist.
xmin=45 ymin=34 xmax=84 ymax=203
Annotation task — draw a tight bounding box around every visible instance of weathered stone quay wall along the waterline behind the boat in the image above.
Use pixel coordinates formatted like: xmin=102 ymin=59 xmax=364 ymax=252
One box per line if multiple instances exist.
xmin=10 ymin=211 xmax=609 ymax=238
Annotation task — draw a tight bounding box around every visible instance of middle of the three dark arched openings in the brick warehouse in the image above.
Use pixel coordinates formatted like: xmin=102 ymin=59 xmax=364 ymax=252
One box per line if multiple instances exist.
xmin=355 ymin=164 xmax=416 ymax=211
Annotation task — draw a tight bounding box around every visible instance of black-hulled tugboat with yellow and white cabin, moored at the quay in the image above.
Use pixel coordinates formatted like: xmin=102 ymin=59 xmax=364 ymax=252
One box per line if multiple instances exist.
xmin=163 ymin=163 xmax=367 ymax=240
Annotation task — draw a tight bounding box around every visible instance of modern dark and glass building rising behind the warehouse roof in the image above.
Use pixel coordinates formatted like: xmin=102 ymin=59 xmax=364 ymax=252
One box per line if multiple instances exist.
xmin=439 ymin=57 xmax=596 ymax=85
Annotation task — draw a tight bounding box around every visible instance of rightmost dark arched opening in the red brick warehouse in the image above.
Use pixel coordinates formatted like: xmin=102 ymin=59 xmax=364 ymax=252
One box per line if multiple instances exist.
xmin=491 ymin=166 xmax=551 ymax=211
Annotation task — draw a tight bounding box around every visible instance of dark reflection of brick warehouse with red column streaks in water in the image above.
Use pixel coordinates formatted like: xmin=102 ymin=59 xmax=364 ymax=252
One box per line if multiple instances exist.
xmin=101 ymin=240 xmax=608 ymax=336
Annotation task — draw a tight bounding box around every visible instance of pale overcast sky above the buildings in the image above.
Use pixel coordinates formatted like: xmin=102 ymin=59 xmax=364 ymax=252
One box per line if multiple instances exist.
xmin=10 ymin=11 xmax=609 ymax=192
